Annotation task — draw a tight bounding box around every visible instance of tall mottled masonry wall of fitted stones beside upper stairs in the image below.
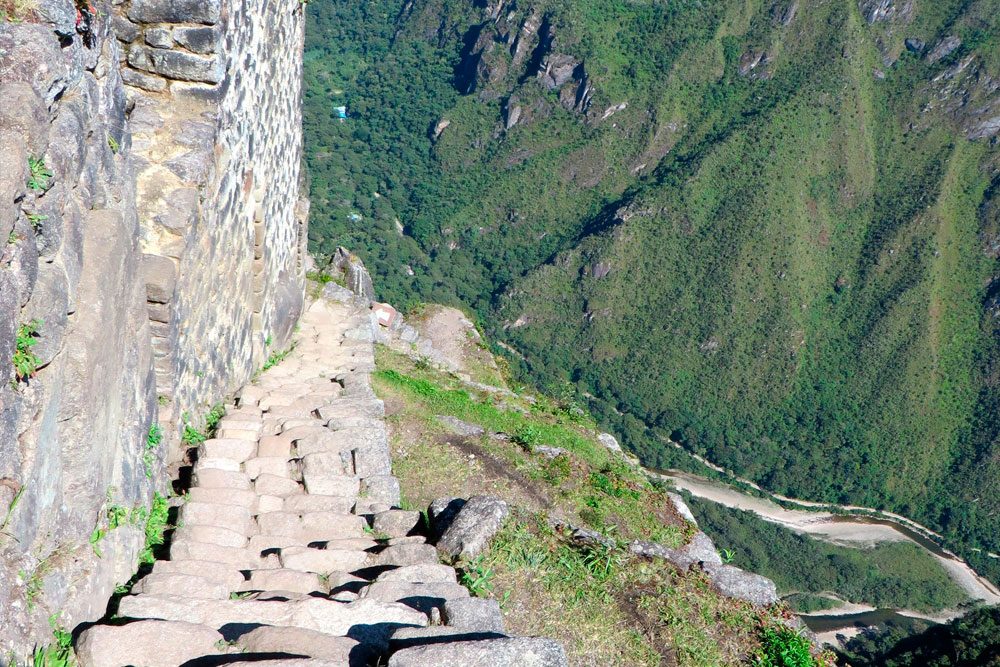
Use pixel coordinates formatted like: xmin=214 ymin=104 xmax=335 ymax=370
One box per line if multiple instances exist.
xmin=114 ymin=0 xmax=308 ymax=460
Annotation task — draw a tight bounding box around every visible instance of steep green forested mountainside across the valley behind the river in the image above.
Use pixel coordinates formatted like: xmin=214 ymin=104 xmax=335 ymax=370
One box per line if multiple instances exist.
xmin=306 ymin=0 xmax=1000 ymax=580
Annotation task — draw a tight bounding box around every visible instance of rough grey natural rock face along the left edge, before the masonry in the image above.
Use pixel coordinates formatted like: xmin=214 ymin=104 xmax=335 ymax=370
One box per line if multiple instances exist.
xmin=0 ymin=13 xmax=161 ymax=656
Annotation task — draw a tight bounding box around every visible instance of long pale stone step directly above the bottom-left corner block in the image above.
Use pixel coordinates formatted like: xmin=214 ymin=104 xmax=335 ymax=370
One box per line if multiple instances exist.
xmin=118 ymin=595 xmax=427 ymax=642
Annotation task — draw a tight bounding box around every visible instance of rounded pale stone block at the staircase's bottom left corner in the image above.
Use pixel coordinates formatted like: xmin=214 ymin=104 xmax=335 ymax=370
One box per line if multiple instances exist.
xmin=76 ymin=620 xmax=224 ymax=667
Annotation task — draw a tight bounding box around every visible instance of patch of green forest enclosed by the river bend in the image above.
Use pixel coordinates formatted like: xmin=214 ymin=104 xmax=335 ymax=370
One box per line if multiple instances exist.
xmin=685 ymin=497 xmax=968 ymax=612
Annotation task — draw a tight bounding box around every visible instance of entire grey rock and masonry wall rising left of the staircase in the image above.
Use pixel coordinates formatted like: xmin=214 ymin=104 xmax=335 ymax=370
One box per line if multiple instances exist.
xmin=0 ymin=0 xmax=308 ymax=654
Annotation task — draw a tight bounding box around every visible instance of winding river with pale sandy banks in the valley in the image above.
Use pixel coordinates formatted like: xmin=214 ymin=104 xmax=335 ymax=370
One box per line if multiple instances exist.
xmin=648 ymin=470 xmax=1000 ymax=643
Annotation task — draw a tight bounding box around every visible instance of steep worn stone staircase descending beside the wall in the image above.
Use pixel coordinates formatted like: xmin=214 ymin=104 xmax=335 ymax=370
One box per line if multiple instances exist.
xmin=76 ymin=300 xmax=566 ymax=667
